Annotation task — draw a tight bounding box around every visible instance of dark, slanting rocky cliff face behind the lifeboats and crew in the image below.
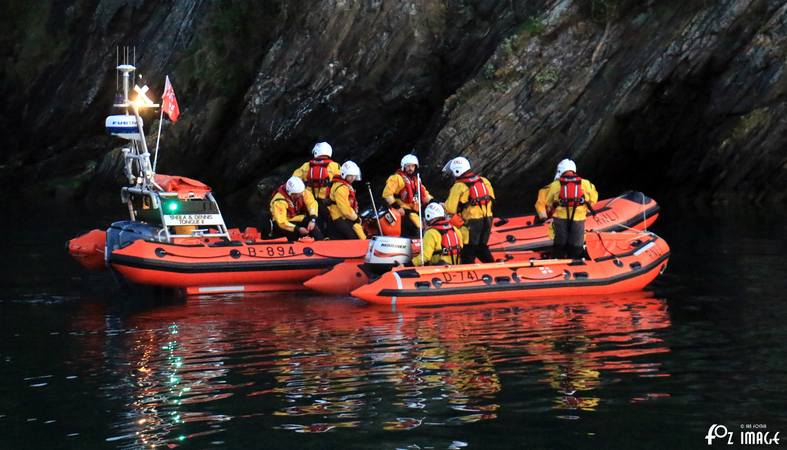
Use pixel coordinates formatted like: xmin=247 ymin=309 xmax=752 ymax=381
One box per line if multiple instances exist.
xmin=0 ymin=0 xmax=787 ymax=209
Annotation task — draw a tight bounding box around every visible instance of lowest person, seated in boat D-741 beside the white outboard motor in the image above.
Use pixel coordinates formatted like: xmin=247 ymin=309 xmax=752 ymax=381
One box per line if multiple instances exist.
xmin=413 ymin=203 xmax=462 ymax=266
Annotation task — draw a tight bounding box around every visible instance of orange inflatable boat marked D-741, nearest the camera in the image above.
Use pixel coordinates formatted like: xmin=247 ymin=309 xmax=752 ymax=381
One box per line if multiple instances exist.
xmin=352 ymin=232 xmax=670 ymax=305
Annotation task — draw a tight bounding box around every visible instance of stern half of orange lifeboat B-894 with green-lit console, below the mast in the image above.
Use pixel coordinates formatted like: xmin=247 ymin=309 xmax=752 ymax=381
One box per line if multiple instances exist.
xmin=68 ymin=171 xmax=367 ymax=294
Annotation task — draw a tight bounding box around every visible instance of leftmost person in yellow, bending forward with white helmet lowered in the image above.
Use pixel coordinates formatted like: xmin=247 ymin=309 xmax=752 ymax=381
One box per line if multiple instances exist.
xmin=270 ymin=177 xmax=323 ymax=241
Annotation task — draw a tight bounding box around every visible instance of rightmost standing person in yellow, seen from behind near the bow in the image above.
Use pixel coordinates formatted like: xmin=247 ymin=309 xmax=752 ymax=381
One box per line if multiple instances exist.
xmin=547 ymin=159 xmax=598 ymax=258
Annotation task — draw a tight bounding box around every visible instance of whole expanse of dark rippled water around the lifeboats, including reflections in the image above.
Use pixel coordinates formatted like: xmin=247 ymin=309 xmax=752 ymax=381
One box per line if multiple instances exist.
xmin=0 ymin=202 xmax=787 ymax=449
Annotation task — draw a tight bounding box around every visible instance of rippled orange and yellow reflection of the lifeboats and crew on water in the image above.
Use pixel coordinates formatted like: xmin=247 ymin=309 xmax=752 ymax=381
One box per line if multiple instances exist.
xmin=100 ymin=292 xmax=670 ymax=446
